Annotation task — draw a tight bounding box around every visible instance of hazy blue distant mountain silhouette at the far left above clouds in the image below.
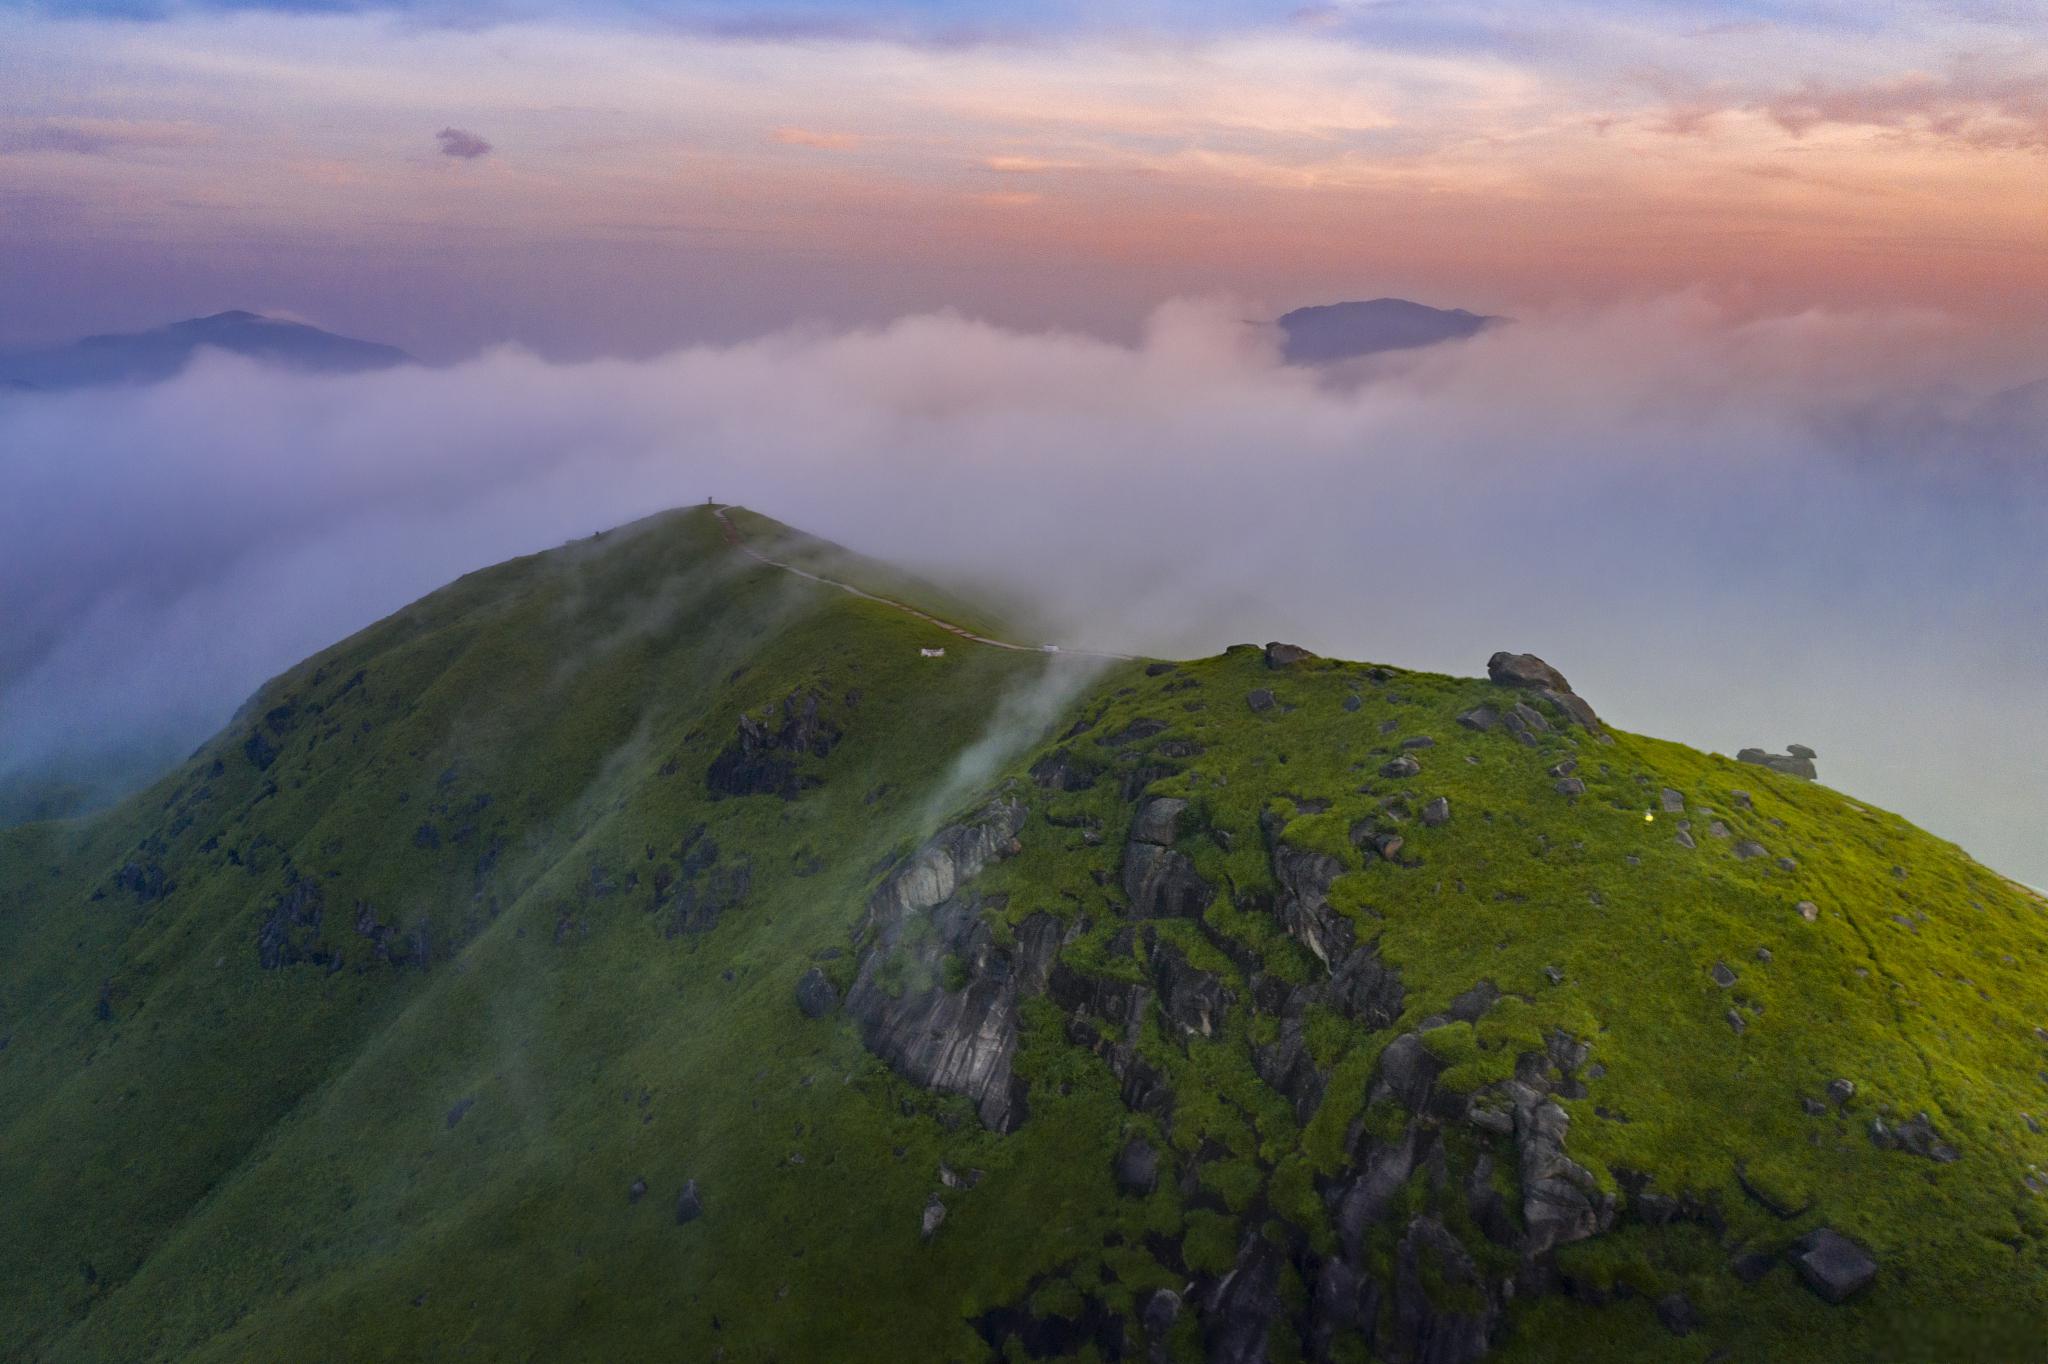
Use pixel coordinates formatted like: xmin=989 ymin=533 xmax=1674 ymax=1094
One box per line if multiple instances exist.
xmin=0 ymin=311 xmax=414 ymax=391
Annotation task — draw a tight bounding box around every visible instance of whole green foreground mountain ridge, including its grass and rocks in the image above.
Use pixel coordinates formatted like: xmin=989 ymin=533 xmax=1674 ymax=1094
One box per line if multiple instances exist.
xmin=0 ymin=510 xmax=2048 ymax=1362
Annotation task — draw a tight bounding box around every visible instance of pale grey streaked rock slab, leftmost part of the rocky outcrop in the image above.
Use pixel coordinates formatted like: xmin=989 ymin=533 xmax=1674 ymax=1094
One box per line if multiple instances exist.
xmin=846 ymin=799 xmax=1061 ymax=1133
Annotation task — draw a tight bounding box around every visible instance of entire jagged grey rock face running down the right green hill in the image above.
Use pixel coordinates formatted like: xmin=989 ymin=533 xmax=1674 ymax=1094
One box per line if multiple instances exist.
xmin=846 ymin=774 xmax=1671 ymax=1364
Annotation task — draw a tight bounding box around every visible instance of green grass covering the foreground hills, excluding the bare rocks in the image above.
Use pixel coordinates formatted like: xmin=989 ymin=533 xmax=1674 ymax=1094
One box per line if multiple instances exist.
xmin=0 ymin=510 xmax=2048 ymax=1360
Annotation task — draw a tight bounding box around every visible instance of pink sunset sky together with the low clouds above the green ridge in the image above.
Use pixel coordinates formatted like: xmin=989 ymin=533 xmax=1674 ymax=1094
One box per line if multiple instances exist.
xmin=0 ymin=0 xmax=2048 ymax=885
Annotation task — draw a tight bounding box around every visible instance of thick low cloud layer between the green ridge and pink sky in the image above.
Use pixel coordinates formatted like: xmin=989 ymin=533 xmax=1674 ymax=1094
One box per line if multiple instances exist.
xmin=0 ymin=297 xmax=2048 ymax=883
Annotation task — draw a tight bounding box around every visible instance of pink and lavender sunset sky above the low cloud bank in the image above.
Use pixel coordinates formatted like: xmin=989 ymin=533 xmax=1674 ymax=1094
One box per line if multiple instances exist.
xmin=0 ymin=0 xmax=2048 ymax=360
